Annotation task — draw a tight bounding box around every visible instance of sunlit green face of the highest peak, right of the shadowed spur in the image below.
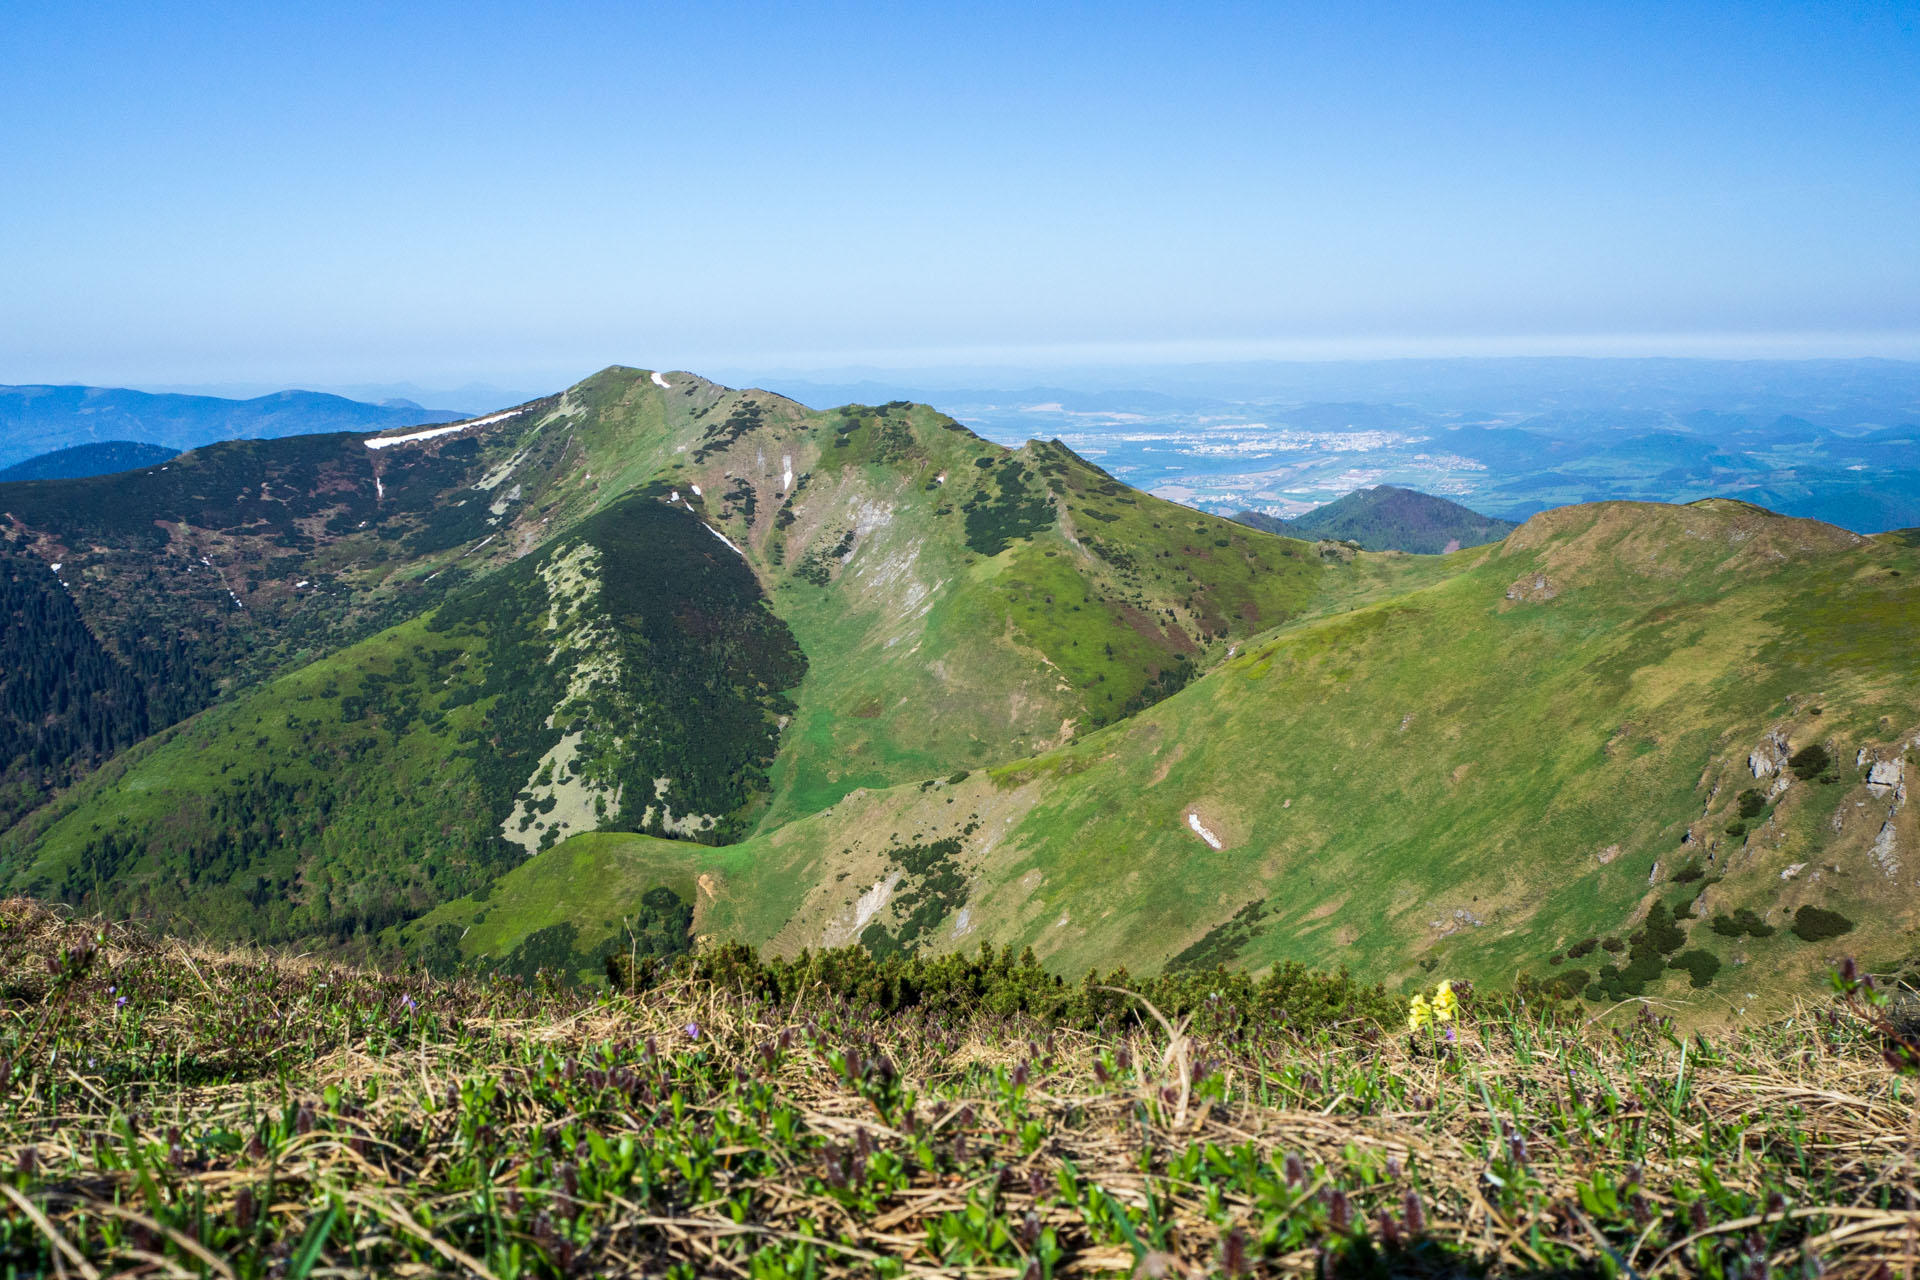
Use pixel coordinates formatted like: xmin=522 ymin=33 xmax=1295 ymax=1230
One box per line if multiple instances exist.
xmin=510 ymin=368 xmax=1323 ymax=825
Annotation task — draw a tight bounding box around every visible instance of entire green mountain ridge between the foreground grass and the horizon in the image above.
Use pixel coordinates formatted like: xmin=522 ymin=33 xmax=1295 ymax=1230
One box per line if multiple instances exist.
xmin=0 ymin=368 xmax=1920 ymax=1007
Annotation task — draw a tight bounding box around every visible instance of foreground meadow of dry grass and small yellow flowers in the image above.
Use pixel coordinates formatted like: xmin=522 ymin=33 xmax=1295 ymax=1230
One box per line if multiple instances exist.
xmin=0 ymin=902 xmax=1920 ymax=1278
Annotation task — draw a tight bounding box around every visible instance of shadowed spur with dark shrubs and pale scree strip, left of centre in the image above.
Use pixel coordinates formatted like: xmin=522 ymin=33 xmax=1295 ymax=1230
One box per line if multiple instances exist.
xmin=5 ymin=493 xmax=804 ymax=940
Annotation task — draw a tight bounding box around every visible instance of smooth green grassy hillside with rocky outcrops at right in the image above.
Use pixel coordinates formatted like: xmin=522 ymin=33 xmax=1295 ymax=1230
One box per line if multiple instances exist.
xmin=420 ymin=501 xmax=1920 ymax=1011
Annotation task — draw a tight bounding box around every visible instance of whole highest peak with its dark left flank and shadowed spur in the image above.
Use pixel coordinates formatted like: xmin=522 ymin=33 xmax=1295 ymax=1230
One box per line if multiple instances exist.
xmin=0 ymin=368 xmax=1336 ymax=940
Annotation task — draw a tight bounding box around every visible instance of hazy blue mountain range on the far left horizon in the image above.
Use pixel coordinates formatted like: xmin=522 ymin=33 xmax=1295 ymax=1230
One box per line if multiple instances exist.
xmin=0 ymin=386 xmax=467 ymax=475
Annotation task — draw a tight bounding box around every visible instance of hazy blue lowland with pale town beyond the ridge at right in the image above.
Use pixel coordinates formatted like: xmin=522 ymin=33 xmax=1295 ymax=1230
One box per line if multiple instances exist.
xmin=764 ymin=359 xmax=1920 ymax=533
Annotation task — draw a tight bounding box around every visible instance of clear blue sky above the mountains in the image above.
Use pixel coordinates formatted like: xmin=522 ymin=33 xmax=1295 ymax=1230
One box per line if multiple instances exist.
xmin=0 ymin=0 xmax=1920 ymax=386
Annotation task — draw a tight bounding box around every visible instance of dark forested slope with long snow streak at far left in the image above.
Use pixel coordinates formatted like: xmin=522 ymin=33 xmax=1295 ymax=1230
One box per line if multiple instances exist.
xmin=0 ymin=401 xmax=591 ymax=823
